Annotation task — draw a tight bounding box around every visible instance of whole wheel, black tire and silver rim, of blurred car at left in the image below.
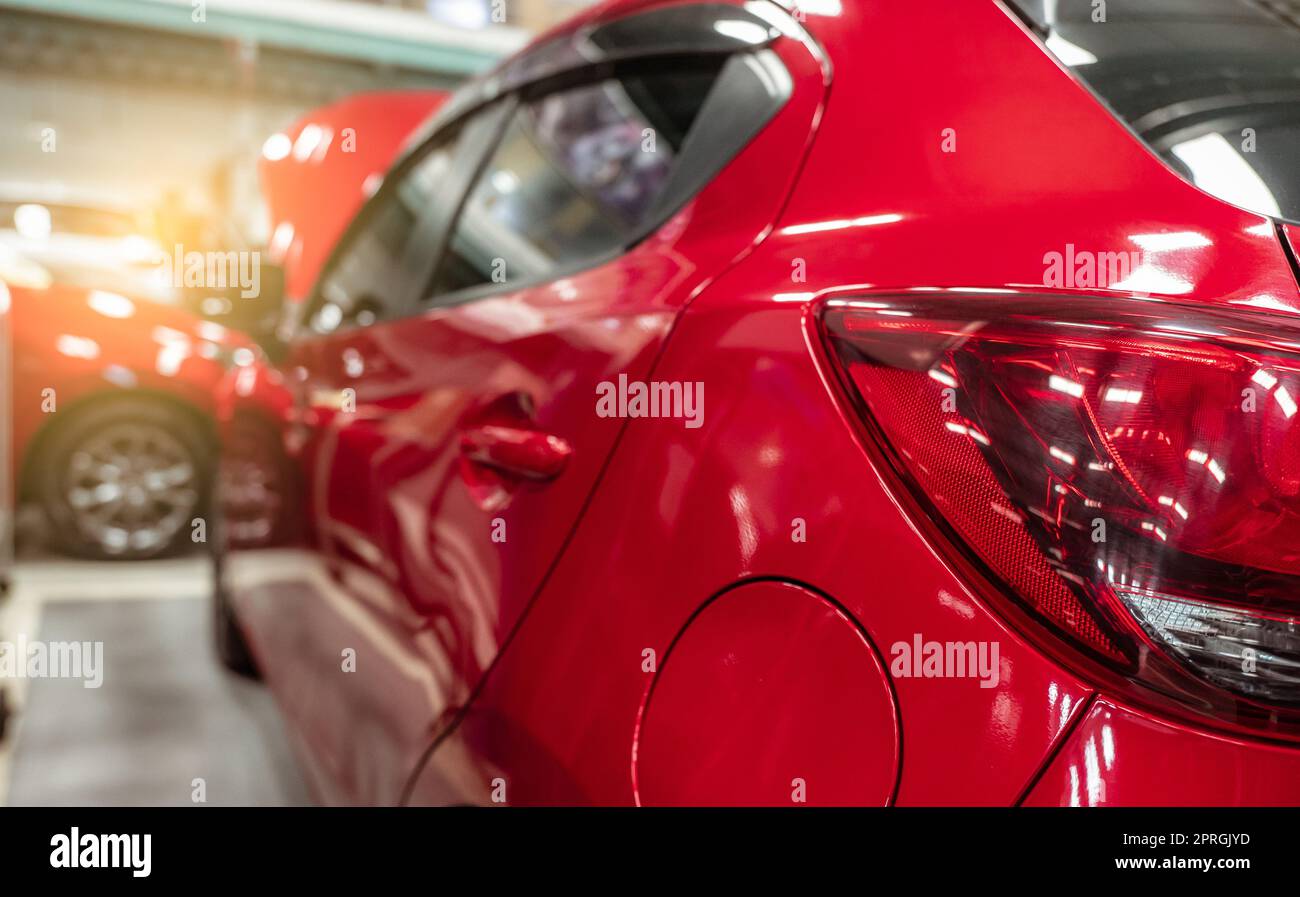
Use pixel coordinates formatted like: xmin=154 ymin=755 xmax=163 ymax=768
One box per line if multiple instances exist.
xmin=33 ymin=397 xmax=213 ymax=560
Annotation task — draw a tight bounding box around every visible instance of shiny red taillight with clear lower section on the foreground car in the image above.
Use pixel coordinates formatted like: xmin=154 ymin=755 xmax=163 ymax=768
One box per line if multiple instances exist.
xmin=819 ymin=291 xmax=1300 ymax=733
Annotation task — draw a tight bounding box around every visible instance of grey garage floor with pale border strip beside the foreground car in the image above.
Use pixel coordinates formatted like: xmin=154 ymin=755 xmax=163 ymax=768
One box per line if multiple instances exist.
xmin=0 ymin=558 xmax=311 ymax=806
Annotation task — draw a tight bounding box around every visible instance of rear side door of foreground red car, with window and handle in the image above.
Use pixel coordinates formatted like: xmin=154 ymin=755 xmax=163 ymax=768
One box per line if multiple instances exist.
xmin=280 ymin=0 xmax=822 ymax=802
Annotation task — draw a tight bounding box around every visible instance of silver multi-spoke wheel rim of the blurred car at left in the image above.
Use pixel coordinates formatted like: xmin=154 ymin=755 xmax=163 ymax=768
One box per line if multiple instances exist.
xmin=64 ymin=421 xmax=199 ymax=555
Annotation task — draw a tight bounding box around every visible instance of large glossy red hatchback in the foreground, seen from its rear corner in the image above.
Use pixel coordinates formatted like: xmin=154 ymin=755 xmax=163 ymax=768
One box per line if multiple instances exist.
xmin=217 ymin=0 xmax=1300 ymax=805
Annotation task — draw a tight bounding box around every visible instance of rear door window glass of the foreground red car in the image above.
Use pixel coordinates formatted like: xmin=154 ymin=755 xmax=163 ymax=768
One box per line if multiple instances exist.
xmin=432 ymin=60 xmax=723 ymax=296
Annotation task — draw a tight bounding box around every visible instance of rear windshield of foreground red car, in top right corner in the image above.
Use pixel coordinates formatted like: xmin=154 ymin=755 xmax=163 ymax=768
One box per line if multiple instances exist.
xmin=1011 ymin=0 xmax=1300 ymax=221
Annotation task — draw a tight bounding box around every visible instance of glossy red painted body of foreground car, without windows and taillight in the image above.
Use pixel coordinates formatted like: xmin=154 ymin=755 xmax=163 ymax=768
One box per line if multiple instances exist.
xmin=213 ymin=0 xmax=1300 ymax=805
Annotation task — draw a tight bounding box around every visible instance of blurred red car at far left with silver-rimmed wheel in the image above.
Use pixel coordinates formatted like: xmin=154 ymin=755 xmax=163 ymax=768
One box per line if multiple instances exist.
xmin=0 ymin=265 xmax=255 ymax=559
